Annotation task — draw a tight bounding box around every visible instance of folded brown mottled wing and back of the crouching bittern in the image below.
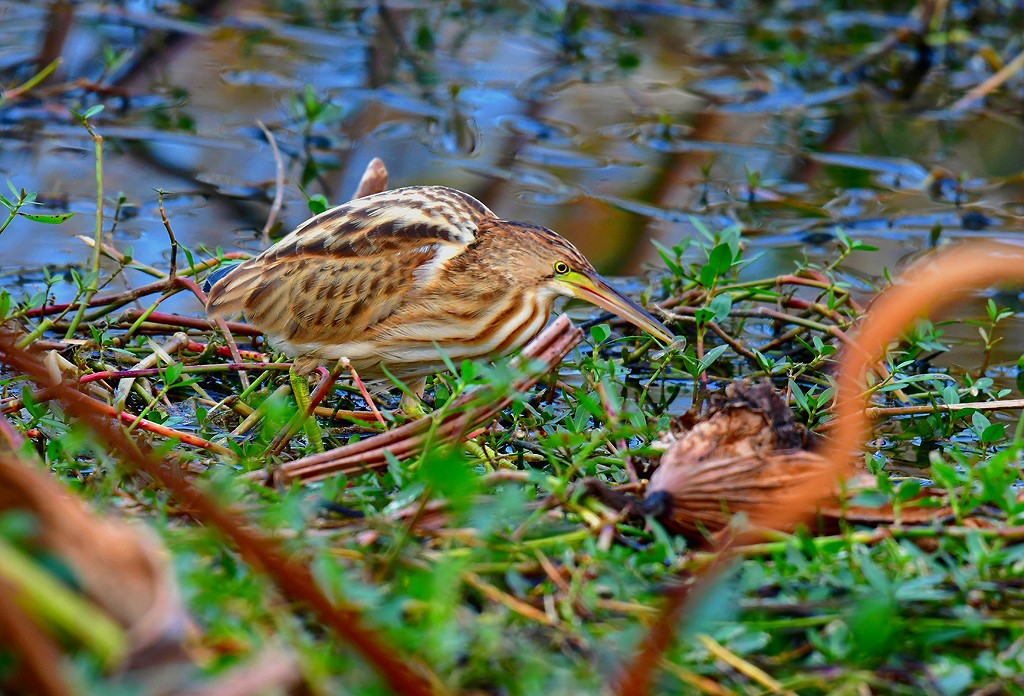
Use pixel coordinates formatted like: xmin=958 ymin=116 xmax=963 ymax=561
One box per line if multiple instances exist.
xmin=207 ymin=186 xmax=495 ymax=343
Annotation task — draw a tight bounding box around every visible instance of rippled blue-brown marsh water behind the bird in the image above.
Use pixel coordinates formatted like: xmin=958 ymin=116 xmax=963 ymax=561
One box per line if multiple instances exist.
xmin=0 ymin=1 xmax=1024 ymax=365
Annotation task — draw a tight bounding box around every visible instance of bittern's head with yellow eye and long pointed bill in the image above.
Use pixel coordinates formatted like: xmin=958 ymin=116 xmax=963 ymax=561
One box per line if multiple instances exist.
xmin=501 ymin=223 xmax=675 ymax=345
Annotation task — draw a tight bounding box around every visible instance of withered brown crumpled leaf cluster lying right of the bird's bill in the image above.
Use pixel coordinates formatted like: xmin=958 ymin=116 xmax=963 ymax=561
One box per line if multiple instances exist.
xmin=641 ymin=382 xmax=948 ymax=538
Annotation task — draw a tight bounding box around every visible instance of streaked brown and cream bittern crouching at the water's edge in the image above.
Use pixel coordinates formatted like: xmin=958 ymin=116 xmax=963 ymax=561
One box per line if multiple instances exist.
xmin=207 ymin=186 xmax=673 ymax=388
